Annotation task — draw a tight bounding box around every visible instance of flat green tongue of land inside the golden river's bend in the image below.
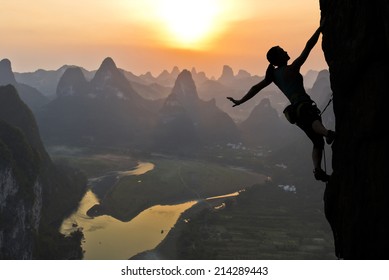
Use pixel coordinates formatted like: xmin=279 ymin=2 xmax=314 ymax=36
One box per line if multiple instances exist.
xmin=94 ymin=158 xmax=266 ymax=221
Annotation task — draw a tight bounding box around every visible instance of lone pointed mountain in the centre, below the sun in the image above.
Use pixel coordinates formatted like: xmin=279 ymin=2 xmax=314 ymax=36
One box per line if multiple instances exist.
xmin=155 ymin=70 xmax=240 ymax=151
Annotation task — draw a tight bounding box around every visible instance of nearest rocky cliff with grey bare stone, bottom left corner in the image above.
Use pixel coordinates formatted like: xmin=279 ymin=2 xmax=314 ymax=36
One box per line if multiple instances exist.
xmin=0 ymin=119 xmax=42 ymax=259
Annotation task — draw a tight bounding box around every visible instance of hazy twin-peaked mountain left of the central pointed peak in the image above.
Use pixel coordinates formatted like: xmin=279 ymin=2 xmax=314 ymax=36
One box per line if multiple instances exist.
xmin=38 ymin=58 xmax=158 ymax=146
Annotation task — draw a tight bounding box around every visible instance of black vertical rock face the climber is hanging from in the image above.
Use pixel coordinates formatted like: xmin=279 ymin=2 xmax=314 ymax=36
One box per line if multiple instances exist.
xmin=320 ymin=0 xmax=389 ymax=259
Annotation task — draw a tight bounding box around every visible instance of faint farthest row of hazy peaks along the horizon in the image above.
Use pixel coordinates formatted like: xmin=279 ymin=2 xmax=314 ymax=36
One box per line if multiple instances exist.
xmin=15 ymin=57 xmax=319 ymax=121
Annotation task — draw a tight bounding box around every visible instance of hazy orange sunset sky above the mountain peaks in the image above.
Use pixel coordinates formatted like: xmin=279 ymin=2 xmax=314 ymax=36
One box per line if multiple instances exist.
xmin=0 ymin=0 xmax=327 ymax=77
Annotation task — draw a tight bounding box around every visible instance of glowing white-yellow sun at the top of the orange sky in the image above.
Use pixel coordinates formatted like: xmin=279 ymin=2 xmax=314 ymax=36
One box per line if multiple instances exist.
xmin=158 ymin=0 xmax=221 ymax=49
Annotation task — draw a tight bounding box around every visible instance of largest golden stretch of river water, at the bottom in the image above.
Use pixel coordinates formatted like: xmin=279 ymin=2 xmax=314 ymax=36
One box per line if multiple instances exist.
xmin=61 ymin=191 xmax=196 ymax=260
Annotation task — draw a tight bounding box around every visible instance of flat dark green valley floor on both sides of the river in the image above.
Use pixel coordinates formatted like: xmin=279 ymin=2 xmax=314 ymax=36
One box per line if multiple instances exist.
xmin=50 ymin=145 xmax=336 ymax=260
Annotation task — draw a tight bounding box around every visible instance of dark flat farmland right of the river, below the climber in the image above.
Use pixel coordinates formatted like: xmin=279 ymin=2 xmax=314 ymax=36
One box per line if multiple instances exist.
xmin=131 ymin=183 xmax=336 ymax=260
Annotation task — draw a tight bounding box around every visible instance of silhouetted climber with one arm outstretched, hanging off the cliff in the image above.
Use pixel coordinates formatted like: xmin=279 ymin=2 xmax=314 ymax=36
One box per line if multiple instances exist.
xmin=227 ymin=27 xmax=335 ymax=182
